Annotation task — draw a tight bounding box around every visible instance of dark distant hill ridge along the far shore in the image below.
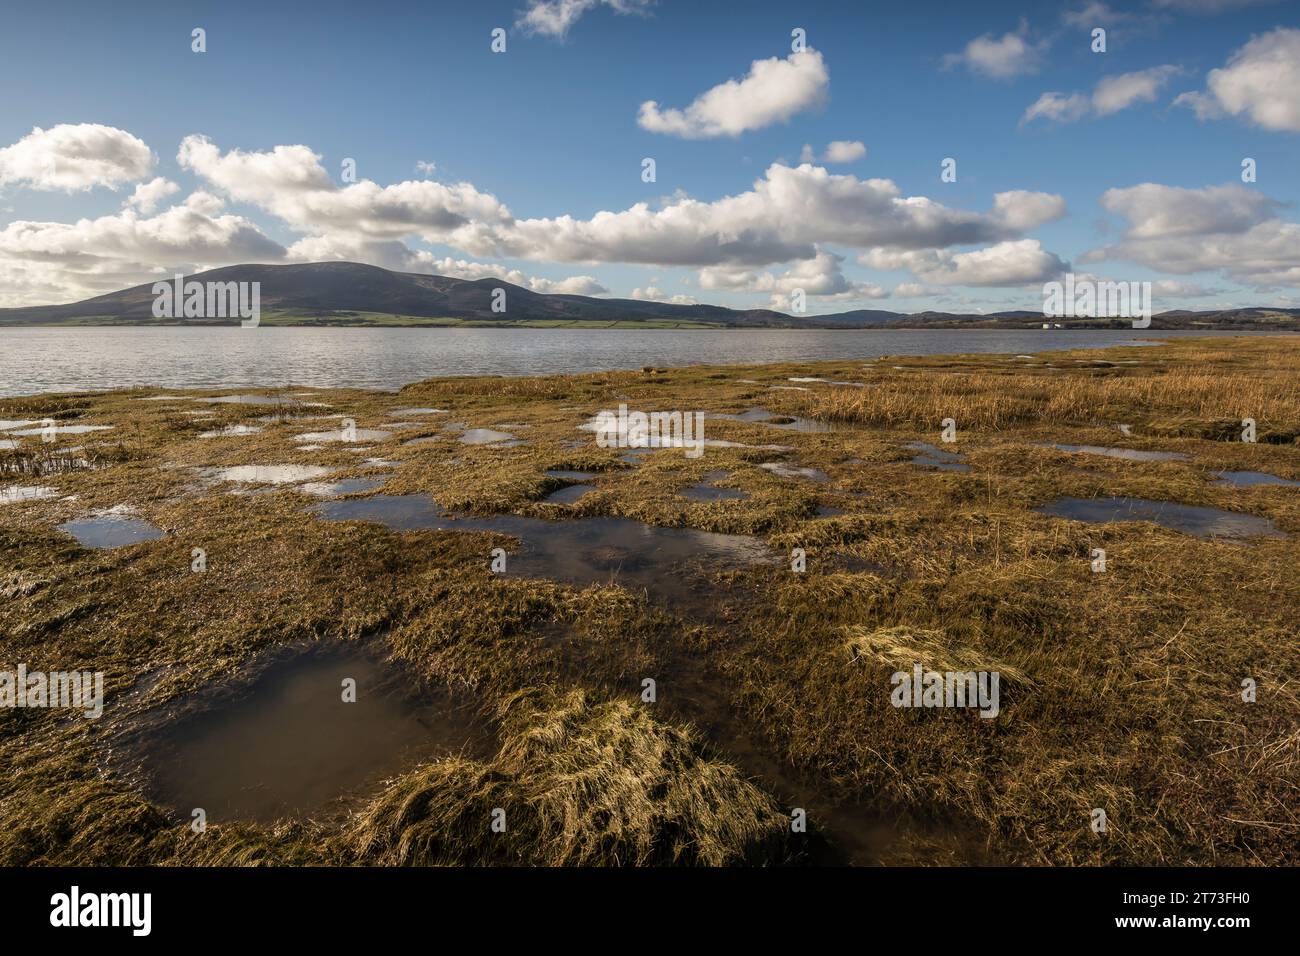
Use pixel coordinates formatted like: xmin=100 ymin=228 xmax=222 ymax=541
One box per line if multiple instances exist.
xmin=0 ymin=261 xmax=1300 ymax=330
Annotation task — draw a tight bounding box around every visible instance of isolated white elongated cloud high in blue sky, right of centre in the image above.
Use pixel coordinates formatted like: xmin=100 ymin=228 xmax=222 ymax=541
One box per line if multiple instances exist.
xmin=637 ymin=49 xmax=831 ymax=139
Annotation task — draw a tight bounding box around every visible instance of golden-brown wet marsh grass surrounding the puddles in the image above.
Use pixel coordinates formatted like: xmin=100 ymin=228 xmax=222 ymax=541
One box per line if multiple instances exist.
xmin=0 ymin=337 xmax=1300 ymax=865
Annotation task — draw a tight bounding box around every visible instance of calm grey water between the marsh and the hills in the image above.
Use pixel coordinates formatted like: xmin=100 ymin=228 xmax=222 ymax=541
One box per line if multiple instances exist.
xmin=0 ymin=326 xmax=1266 ymax=395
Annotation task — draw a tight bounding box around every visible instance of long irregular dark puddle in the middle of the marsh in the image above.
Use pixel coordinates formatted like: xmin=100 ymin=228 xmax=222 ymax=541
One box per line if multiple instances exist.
xmin=312 ymin=494 xmax=771 ymax=600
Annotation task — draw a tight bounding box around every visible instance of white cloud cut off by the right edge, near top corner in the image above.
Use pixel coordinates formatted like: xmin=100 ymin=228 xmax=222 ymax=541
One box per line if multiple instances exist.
xmin=1174 ymin=27 xmax=1300 ymax=133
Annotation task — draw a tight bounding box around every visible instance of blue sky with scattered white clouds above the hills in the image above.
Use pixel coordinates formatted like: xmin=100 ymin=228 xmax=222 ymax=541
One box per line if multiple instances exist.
xmin=0 ymin=0 xmax=1300 ymax=315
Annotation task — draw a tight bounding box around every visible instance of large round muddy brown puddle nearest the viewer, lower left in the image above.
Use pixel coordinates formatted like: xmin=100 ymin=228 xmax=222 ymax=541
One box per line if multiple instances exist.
xmin=138 ymin=648 xmax=489 ymax=823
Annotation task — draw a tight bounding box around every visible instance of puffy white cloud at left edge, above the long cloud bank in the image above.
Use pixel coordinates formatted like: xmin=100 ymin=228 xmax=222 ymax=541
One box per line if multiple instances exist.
xmin=0 ymin=122 xmax=155 ymax=193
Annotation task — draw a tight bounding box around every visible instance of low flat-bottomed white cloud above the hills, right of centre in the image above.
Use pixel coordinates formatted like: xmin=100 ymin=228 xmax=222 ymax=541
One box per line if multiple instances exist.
xmin=858 ymin=239 xmax=1069 ymax=286
